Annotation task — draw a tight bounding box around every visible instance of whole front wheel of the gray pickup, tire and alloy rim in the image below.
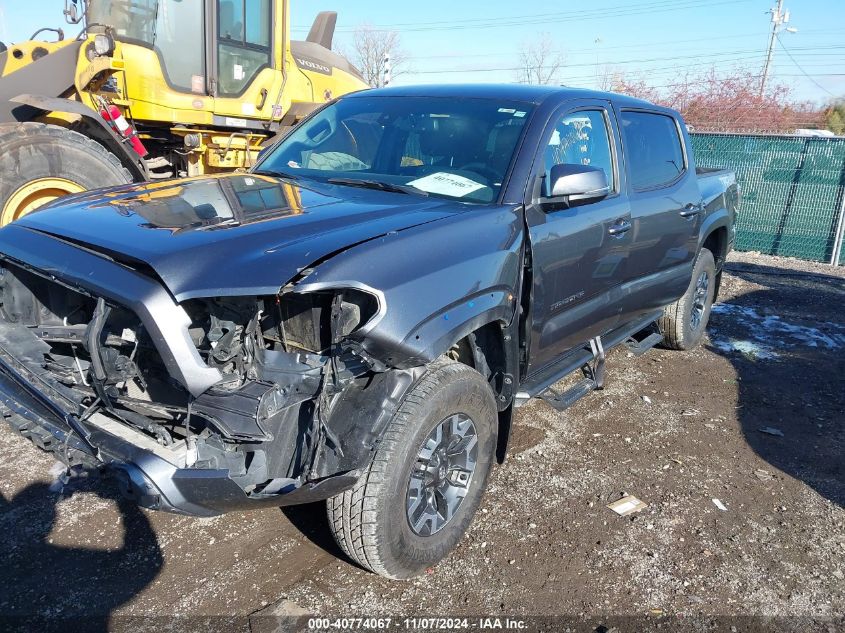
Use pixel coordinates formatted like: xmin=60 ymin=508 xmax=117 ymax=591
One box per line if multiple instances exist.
xmin=327 ymin=359 xmax=497 ymax=579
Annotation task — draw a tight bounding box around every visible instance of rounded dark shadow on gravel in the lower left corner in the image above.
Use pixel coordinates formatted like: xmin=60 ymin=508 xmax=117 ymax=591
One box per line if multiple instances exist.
xmin=0 ymin=476 xmax=163 ymax=631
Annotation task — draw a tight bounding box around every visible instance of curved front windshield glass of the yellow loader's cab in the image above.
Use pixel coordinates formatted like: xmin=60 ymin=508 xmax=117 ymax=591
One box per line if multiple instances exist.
xmin=86 ymin=0 xmax=205 ymax=93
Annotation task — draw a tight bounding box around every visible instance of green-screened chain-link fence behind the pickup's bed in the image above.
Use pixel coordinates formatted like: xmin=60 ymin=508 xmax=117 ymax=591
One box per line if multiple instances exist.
xmin=691 ymin=133 xmax=845 ymax=264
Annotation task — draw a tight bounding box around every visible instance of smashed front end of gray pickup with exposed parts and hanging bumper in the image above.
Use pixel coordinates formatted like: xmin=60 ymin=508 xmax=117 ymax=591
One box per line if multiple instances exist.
xmin=0 ymin=236 xmax=412 ymax=515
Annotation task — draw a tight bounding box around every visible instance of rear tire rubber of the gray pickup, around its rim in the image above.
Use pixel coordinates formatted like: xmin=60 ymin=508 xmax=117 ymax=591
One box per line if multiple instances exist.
xmin=657 ymin=248 xmax=717 ymax=350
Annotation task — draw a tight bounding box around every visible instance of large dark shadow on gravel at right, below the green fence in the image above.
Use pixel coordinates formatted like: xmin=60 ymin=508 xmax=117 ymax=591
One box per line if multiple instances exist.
xmin=710 ymin=265 xmax=845 ymax=507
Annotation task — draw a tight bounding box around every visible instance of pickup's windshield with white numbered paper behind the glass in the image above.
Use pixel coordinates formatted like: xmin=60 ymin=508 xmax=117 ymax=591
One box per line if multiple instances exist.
xmin=256 ymin=96 xmax=531 ymax=202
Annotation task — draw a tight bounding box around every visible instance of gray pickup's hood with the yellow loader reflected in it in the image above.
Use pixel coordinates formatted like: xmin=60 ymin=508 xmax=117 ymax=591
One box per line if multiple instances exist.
xmin=8 ymin=174 xmax=467 ymax=301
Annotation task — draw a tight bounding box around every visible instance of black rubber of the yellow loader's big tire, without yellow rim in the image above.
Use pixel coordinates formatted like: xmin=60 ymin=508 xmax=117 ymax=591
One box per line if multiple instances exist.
xmin=0 ymin=122 xmax=132 ymax=225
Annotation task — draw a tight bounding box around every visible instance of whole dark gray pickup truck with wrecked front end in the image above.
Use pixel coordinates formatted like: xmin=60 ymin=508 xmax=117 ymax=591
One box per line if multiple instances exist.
xmin=0 ymin=86 xmax=738 ymax=578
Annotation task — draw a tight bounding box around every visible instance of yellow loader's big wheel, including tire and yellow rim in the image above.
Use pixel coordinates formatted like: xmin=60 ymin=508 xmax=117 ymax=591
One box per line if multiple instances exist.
xmin=0 ymin=122 xmax=132 ymax=226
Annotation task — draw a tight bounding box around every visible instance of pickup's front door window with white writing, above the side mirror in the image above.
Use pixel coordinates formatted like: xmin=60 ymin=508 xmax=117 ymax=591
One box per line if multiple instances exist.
xmin=543 ymin=110 xmax=617 ymax=196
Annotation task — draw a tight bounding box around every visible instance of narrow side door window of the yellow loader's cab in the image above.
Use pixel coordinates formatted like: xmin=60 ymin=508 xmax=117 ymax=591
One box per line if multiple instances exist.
xmin=217 ymin=0 xmax=273 ymax=96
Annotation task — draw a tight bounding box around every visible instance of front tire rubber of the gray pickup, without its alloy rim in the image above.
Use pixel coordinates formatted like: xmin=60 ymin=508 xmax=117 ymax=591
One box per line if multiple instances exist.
xmin=327 ymin=358 xmax=498 ymax=579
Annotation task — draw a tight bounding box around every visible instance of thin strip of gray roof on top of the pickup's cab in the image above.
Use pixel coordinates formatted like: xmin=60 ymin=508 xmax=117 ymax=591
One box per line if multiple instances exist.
xmin=349 ymin=83 xmax=665 ymax=110
